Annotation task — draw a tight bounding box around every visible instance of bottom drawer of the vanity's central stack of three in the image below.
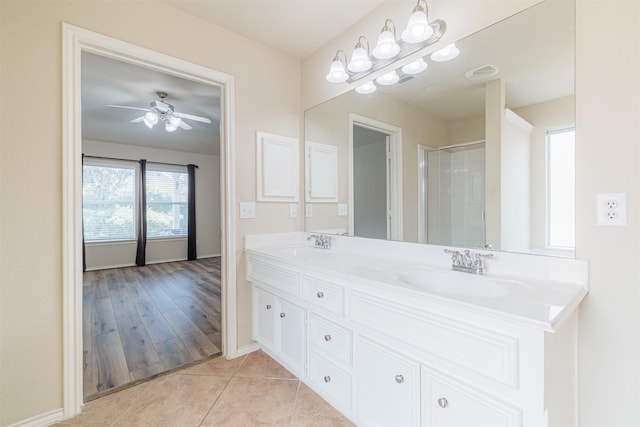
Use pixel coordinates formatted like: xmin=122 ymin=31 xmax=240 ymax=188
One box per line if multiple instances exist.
xmin=309 ymin=351 xmax=352 ymax=409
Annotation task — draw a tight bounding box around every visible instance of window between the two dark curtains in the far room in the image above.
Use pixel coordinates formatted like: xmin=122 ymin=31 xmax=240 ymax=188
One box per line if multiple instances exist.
xmin=147 ymin=167 xmax=189 ymax=238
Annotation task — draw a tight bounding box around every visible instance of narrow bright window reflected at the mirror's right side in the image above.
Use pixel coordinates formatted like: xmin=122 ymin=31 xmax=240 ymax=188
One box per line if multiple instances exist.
xmin=547 ymin=126 xmax=575 ymax=249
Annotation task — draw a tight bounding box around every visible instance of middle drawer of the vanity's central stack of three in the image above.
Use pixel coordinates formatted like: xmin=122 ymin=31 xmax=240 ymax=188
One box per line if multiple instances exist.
xmin=309 ymin=314 xmax=351 ymax=365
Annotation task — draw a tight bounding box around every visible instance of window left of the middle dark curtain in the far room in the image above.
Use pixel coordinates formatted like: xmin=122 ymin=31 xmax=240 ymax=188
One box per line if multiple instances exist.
xmin=82 ymin=164 xmax=136 ymax=241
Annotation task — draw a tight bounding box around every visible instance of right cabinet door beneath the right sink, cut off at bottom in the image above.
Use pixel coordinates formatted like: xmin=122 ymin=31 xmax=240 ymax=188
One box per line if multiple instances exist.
xmin=422 ymin=368 xmax=522 ymax=427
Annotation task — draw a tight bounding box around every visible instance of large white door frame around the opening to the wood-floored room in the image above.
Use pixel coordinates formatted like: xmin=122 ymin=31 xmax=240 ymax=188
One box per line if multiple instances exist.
xmin=62 ymin=23 xmax=237 ymax=418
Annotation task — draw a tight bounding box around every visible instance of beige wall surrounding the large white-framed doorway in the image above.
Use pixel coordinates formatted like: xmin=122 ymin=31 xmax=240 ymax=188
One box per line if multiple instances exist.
xmin=0 ymin=0 xmax=302 ymax=425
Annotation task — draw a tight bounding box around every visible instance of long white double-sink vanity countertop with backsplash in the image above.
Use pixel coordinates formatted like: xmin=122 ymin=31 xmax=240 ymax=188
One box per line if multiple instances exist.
xmin=245 ymin=232 xmax=588 ymax=332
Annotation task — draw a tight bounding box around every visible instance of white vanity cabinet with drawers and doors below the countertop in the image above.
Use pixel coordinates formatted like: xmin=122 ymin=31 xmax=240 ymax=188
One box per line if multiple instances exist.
xmin=247 ymin=247 xmax=577 ymax=427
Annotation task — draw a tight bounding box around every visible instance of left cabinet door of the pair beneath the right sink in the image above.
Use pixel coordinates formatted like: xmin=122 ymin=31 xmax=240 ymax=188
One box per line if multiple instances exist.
xmin=356 ymin=339 xmax=420 ymax=427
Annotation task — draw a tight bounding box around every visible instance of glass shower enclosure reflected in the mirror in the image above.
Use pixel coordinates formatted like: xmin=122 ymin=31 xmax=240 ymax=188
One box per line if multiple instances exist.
xmin=421 ymin=142 xmax=486 ymax=247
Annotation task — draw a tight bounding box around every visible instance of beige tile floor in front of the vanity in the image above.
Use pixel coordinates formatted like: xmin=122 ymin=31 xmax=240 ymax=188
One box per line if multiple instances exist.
xmin=56 ymin=351 xmax=353 ymax=427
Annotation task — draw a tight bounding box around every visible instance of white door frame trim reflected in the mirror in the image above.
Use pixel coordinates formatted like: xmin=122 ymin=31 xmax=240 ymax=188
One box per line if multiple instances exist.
xmin=348 ymin=113 xmax=404 ymax=240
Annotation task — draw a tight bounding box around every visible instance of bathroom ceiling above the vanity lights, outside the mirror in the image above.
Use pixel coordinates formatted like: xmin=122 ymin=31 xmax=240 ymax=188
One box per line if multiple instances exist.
xmin=161 ymin=0 xmax=392 ymax=59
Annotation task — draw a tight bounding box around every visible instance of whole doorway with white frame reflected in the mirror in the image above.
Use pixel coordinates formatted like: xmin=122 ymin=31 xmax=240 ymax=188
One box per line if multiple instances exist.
xmin=349 ymin=114 xmax=403 ymax=240
